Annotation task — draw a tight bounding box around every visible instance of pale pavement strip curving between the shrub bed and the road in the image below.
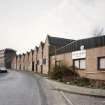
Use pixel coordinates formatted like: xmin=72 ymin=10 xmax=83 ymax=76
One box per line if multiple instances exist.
xmin=46 ymin=79 xmax=105 ymax=98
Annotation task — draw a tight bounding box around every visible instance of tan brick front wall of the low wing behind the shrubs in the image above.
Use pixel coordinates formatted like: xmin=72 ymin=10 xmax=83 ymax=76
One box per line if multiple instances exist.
xmin=50 ymin=47 xmax=105 ymax=80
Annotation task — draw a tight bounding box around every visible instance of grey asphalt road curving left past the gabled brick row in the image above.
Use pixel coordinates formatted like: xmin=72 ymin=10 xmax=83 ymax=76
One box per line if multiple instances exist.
xmin=0 ymin=71 xmax=105 ymax=105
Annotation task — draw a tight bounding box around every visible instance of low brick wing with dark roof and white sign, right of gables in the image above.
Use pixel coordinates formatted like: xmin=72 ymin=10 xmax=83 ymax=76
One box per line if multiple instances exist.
xmin=50 ymin=36 xmax=105 ymax=80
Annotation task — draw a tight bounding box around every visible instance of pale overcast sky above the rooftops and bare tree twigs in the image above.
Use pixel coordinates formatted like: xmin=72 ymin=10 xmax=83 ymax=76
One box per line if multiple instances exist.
xmin=0 ymin=0 xmax=105 ymax=54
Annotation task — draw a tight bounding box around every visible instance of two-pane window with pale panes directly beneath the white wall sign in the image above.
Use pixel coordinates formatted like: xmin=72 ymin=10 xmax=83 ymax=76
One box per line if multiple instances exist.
xmin=74 ymin=59 xmax=86 ymax=69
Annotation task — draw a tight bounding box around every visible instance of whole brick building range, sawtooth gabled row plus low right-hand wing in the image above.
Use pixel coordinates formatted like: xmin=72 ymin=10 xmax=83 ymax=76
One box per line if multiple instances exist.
xmin=13 ymin=35 xmax=105 ymax=80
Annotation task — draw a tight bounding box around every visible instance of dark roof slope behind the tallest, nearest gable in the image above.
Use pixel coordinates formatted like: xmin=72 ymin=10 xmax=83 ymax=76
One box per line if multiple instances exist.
xmin=47 ymin=35 xmax=74 ymax=46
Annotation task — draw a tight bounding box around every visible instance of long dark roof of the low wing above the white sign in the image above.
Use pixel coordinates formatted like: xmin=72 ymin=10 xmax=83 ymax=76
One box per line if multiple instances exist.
xmin=51 ymin=35 xmax=105 ymax=55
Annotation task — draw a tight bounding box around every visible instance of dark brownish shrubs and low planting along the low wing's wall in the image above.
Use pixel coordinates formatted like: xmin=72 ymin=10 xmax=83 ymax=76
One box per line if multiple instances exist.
xmin=49 ymin=65 xmax=105 ymax=89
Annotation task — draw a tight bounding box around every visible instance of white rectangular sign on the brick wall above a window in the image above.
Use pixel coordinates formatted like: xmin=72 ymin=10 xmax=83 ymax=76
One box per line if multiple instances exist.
xmin=72 ymin=50 xmax=86 ymax=59
